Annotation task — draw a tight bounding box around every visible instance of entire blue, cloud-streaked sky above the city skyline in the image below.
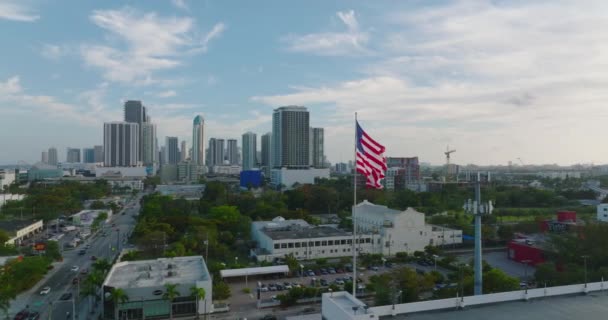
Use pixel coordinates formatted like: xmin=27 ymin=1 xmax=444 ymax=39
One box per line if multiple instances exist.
xmin=0 ymin=0 xmax=608 ymax=165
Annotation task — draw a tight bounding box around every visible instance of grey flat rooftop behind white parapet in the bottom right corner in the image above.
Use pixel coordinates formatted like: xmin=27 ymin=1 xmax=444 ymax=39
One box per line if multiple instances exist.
xmin=392 ymin=292 xmax=608 ymax=320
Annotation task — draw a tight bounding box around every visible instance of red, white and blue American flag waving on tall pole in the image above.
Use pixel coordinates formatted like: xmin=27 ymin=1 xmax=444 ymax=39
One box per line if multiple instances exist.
xmin=356 ymin=121 xmax=387 ymax=189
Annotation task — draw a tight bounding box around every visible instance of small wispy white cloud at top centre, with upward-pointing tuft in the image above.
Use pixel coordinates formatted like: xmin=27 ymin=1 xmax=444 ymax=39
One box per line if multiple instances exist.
xmin=282 ymin=10 xmax=369 ymax=56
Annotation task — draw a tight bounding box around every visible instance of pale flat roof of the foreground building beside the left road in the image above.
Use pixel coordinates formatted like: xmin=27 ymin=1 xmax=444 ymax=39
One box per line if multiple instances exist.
xmin=104 ymin=256 xmax=211 ymax=288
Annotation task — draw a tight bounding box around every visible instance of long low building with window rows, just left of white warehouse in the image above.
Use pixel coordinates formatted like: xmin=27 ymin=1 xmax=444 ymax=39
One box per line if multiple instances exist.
xmin=251 ymin=217 xmax=378 ymax=261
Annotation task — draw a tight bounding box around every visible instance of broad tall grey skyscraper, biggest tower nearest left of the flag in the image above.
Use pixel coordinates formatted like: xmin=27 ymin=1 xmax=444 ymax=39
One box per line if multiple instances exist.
xmin=272 ymin=106 xmax=310 ymax=168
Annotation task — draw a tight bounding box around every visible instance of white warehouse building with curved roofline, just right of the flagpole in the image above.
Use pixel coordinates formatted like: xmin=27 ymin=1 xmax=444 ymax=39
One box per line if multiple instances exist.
xmin=355 ymin=200 xmax=462 ymax=256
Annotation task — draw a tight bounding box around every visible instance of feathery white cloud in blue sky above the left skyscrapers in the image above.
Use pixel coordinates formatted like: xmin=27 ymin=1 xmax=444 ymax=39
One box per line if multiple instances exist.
xmin=81 ymin=8 xmax=223 ymax=85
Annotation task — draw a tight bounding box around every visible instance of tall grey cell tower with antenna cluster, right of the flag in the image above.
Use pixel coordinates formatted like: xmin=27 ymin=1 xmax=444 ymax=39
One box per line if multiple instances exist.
xmin=463 ymin=173 xmax=494 ymax=296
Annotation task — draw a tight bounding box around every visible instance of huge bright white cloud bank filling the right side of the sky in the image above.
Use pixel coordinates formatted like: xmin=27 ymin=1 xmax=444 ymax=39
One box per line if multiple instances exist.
xmin=252 ymin=1 xmax=608 ymax=164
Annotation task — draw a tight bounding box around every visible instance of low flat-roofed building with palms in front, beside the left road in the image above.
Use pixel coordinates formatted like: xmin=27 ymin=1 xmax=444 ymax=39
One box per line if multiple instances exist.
xmin=102 ymin=256 xmax=213 ymax=320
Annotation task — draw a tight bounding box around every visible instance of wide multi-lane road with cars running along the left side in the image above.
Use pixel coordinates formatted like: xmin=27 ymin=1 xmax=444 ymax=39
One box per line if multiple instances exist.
xmin=10 ymin=197 xmax=140 ymax=320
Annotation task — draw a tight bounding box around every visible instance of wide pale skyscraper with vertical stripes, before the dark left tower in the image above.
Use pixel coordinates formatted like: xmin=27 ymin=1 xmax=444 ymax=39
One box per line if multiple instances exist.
xmin=103 ymin=121 xmax=139 ymax=167
